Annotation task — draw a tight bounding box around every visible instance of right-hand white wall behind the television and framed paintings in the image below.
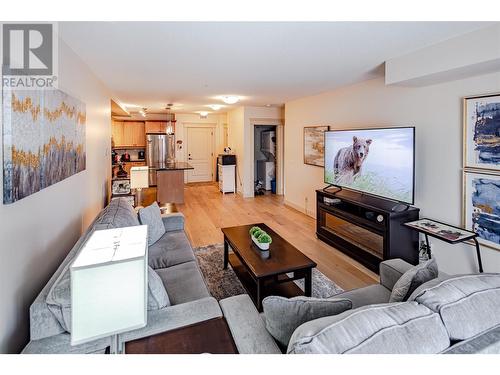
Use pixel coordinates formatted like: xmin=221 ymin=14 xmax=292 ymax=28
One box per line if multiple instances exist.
xmin=285 ymin=73 xmax=500 ymax=273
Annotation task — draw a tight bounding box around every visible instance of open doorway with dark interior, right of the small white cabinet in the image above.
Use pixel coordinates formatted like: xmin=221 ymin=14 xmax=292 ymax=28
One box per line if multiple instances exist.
xmin=253 ymin=125 xmax=277 ymax=197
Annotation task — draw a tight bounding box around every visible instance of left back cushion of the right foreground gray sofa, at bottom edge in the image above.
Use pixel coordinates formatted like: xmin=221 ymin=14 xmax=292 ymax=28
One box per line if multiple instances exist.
xmin=287 ymin=302 xmax=450 ymax=354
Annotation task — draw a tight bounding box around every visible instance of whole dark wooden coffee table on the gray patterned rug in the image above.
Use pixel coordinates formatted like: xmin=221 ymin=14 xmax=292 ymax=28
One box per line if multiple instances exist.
xmin=222 ymin=223 xmax=316 ymax=311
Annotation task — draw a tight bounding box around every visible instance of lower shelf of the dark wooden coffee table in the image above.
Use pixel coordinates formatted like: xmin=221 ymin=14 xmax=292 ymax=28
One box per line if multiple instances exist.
xmin=229 ymin=253 xmax=304 ymax=310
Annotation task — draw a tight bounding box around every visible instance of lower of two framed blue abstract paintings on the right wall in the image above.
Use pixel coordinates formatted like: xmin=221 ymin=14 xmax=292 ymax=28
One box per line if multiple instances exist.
xmin=463 ymin=171 xmax=500 ymax=250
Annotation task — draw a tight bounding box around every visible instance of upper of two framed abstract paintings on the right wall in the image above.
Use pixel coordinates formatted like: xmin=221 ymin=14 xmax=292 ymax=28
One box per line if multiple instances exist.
xmin=463 ymin=94 xmax=500 ymax=171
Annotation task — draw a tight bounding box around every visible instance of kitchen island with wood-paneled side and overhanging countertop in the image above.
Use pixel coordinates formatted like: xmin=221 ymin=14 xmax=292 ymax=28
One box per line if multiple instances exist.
xmin=156 ymin=162 xmax=194 ymax=204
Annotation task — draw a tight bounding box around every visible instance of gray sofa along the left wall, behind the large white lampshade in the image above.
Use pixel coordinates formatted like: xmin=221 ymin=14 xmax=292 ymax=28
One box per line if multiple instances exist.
xmin=23 ymin=198 xmax=222 ymax=353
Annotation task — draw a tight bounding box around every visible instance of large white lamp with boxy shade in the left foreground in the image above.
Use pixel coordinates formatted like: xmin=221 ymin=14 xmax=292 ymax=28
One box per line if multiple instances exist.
xmin=70 ymin=225 xmax=148 ymax=353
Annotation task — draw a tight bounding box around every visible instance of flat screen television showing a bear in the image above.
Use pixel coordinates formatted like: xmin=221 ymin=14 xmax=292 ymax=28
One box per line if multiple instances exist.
xmin=325 ymin=127 xmax=415 ymax=204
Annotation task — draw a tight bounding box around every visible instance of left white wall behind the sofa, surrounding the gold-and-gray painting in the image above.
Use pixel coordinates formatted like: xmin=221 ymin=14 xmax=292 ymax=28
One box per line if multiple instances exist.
xmin=0 ymin=36 xmax=111 ymax=353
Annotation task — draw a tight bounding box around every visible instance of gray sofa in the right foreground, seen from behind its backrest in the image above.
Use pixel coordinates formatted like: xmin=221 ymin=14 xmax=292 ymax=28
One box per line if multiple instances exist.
xmin=220 ymin=259 xmax=500 ymax=354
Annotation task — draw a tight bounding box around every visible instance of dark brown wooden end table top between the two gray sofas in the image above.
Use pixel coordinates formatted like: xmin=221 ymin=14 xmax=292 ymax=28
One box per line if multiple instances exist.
xmin=125 ymin=317 xmax=238 ymax=354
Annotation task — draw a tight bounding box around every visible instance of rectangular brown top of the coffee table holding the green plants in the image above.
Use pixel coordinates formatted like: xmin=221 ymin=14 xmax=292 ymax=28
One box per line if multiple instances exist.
xmin=222 ymin=223 xmax=316 ymax=278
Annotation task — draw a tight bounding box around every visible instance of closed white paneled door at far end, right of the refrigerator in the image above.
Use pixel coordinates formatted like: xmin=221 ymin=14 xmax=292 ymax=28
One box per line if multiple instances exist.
xmin=187 ymin=127 xmax=214 ymax=182
